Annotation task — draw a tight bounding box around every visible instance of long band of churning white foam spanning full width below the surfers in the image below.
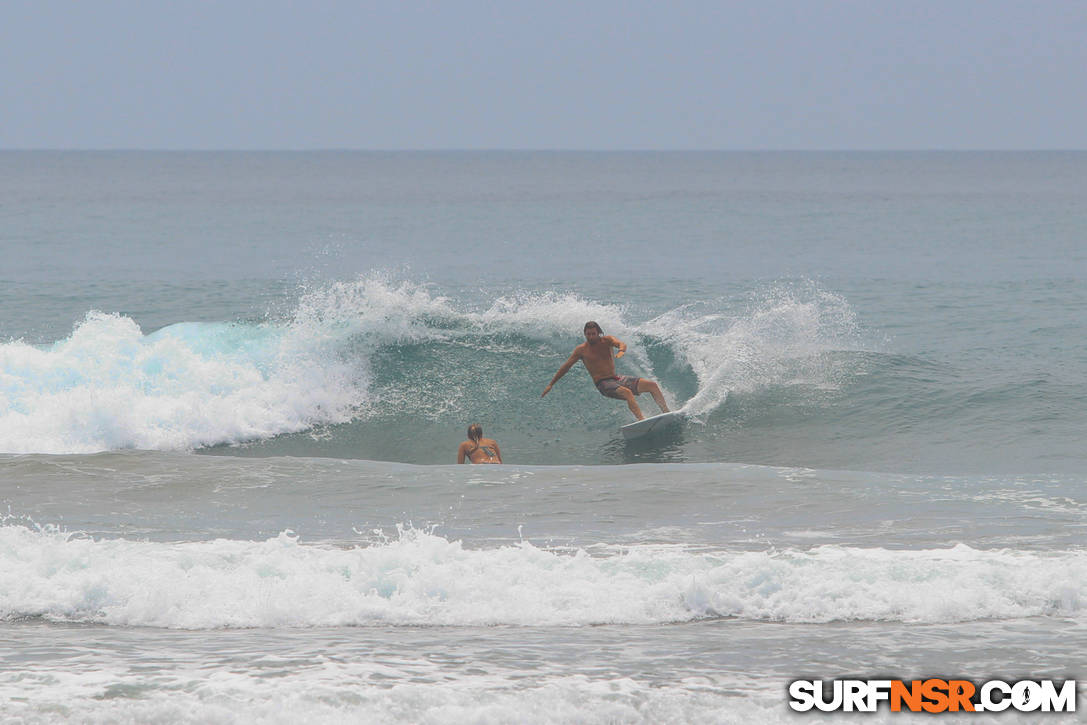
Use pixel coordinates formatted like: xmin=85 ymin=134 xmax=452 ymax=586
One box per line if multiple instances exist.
xmin=0 ymin=525 xmax=1087 ymax=629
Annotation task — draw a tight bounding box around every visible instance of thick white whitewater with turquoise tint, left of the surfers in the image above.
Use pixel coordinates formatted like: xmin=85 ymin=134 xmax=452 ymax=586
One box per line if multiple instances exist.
xmin=0 ymin=312 xmax=366 ymax=453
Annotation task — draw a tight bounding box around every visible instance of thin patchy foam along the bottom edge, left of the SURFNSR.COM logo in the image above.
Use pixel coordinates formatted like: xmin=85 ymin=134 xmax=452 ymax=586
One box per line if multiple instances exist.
xmin=0 ymin=669 xmax=787 ymax=725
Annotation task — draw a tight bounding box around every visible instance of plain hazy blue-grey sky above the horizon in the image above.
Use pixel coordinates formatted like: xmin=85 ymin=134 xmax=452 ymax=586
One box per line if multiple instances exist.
xmin=0 ymin=0 xmax=1087 ymax=149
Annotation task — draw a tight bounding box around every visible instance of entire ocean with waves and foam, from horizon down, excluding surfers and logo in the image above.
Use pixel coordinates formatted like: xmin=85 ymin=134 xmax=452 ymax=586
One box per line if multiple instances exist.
xmin=0 ymin=151 xmax=1087 ymax=723
